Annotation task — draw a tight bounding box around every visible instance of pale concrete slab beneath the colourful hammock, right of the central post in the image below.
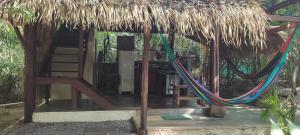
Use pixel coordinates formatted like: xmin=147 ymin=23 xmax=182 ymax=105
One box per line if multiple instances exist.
xmin=135 ymin=106 xmax=270 ymax=135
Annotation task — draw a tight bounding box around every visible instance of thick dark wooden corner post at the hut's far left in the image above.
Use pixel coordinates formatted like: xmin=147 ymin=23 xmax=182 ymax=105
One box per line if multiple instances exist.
xmin=23 ymin=24 xmax=36 ymax=123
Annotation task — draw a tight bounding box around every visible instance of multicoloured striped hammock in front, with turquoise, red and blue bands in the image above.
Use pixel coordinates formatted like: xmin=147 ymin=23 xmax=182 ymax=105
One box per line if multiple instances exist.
xmin=161 ymin=27 xmax=300 ymax=106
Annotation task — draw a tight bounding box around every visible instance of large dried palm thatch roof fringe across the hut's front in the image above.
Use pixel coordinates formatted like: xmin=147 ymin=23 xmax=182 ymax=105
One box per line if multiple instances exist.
xmin=0 ymin=0 xmax=267 ymax=48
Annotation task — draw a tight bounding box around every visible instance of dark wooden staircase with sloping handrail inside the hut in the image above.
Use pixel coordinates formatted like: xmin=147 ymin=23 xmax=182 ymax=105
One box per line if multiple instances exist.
xmin=36 ymin=28 xmax=113 ymax=109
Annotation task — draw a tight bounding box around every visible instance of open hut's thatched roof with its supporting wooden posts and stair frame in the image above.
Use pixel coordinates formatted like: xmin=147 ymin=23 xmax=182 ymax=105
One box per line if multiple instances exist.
xmin=0 ymin=0 xmax=298 ymax=133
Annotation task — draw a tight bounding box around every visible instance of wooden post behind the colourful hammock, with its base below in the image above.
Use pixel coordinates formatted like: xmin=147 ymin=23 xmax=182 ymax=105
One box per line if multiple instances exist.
xmin=209 ymin=26 xmax=225 ymax=117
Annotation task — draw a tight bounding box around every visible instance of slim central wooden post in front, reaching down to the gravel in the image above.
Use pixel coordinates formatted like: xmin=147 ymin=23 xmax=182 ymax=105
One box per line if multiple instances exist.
xmin=140 ymin=26 xmax=151 ymax=135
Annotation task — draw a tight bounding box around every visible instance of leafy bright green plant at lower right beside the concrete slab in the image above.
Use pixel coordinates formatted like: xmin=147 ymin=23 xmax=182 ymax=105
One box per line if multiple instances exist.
xmin=258 ymin=89 xmax=297 ymax=134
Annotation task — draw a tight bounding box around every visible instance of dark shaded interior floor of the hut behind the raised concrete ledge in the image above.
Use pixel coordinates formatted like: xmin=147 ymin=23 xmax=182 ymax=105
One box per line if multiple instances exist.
xmin=36 ymin=95 xmax=200 ymax=112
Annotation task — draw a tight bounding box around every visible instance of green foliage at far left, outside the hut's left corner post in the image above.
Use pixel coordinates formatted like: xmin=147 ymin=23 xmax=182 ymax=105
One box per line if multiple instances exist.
xmin=0 ymin=22 xmax=24 ymax=104
